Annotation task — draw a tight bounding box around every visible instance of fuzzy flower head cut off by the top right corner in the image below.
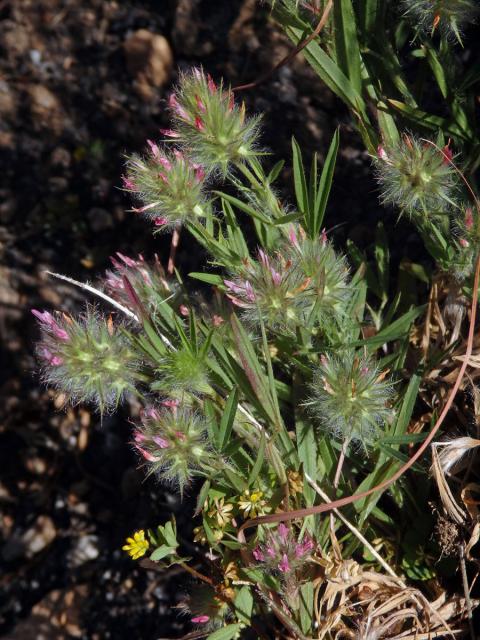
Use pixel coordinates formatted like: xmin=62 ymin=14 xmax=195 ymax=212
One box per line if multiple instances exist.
xmin=402 ymin=0 xmax=480 ymax=43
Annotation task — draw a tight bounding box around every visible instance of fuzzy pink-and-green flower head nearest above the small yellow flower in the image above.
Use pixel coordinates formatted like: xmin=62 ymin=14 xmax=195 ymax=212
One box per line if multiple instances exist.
xmin=133 ymin=400 xmax=215 ymax=494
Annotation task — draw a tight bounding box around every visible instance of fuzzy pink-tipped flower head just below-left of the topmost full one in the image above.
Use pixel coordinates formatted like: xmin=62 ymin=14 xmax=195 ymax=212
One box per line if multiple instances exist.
xmin=123 ymin=140 xmax=207 ymax=230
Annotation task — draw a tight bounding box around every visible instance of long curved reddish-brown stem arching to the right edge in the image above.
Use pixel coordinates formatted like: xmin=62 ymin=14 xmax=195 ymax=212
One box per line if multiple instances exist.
xmin=239 ymin=255 xmax=480 ymax=539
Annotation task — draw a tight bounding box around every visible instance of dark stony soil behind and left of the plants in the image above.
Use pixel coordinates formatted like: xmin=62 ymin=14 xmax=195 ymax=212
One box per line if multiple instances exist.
xmin=0 ymin=0 xmax=398 ymax=640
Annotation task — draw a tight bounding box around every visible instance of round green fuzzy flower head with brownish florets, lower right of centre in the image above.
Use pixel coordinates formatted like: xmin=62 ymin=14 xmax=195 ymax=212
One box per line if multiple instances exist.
xmin=307 ymin=351 xmax=392 ymax=447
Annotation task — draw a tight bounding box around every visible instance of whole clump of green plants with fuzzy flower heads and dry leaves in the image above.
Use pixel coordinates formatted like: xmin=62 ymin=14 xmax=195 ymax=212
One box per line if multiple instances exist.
xmin=34 ymin=6 xmax=480 ymax=640
